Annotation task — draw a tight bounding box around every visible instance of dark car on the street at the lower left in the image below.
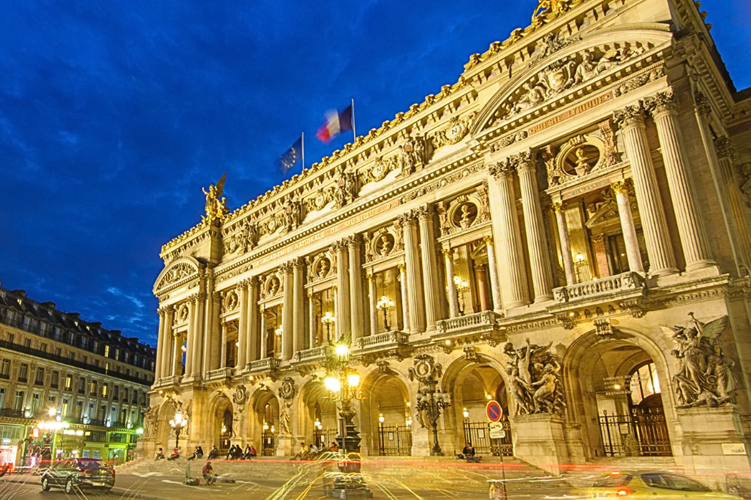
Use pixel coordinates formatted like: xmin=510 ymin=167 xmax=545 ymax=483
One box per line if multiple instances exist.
xmin=42 ymin=458 xmax=115 ymax=494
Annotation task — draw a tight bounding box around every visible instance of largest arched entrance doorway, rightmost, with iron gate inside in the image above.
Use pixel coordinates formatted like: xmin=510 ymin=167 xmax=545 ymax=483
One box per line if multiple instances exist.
xmin=564 ymin=333 xmax=673 ymax=458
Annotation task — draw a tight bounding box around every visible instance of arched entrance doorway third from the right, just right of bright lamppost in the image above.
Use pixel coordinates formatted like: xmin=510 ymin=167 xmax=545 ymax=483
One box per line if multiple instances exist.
xmin=361 ymin=374 xmax=412 ymax=456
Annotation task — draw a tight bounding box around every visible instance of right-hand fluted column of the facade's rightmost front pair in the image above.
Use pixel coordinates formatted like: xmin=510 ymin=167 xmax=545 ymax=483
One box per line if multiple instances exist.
xmin=646 ymin=89 xmax=716 ymax=271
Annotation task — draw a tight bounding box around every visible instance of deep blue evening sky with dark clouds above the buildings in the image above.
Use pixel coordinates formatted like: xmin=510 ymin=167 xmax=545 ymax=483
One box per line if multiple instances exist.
xmin=0 ymin=0 xmax=751 ymax=345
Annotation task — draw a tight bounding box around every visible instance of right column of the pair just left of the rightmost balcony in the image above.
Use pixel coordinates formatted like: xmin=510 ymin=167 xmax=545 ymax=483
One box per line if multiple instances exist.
xmin=517 ymin=150 xmax=553 ymax=302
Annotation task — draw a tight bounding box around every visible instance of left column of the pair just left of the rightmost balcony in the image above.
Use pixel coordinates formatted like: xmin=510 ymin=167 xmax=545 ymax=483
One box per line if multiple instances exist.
xmin=488 ymin=158 xmax=529 ymax=308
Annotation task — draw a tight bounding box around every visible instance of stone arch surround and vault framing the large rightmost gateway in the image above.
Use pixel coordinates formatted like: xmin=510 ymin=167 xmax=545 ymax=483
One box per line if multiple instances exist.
xmin=562 ymin=328 xmax=680 ymax=458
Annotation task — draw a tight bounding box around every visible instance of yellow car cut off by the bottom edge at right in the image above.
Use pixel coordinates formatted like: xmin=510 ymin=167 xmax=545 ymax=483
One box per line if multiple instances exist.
xmin=587 ymin=471 xmax=741 ymax=500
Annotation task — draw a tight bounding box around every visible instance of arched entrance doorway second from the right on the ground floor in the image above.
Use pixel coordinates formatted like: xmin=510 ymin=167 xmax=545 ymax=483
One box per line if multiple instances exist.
xmin=456 ymin=365 xmax=514 ymax=456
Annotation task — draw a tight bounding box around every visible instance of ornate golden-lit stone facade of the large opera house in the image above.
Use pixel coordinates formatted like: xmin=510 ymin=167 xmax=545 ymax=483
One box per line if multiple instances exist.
xmin=145 ymin=0 xmax=751 ymax=488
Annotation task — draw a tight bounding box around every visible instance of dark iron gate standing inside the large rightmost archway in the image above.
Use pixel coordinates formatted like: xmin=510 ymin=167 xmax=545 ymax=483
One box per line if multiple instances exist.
xmin=600 ymin=408 xmax=673 ymax=457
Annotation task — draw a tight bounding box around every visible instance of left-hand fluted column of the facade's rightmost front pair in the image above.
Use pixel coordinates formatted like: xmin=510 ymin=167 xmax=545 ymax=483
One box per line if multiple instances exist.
xmin=614 ymin=105 xmax=678 ymax=276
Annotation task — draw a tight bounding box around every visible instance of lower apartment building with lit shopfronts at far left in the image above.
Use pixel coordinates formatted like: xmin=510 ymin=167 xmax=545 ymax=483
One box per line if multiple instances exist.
xmin=0 ymin=287 xmax=156 ymax=466
